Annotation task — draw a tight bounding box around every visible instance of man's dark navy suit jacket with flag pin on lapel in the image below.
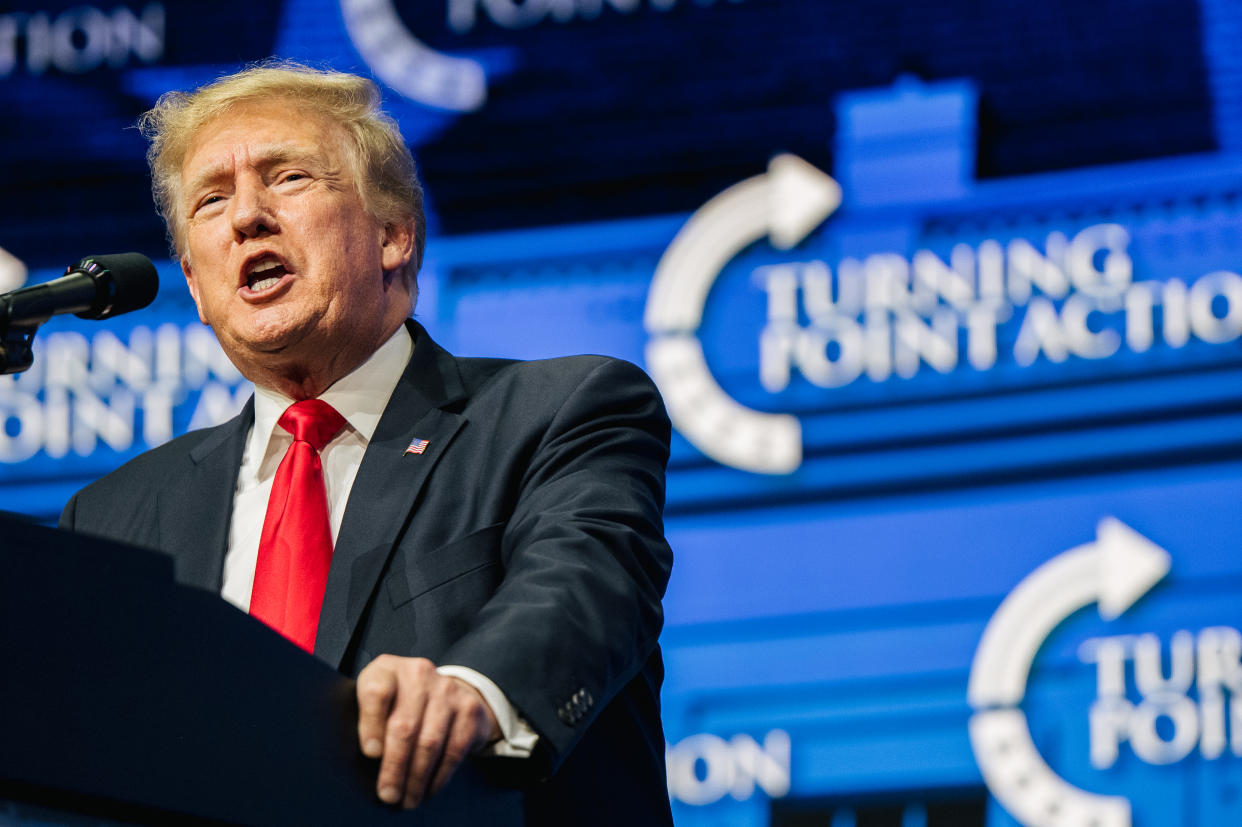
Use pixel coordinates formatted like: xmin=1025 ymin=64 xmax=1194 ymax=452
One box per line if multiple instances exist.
xmin=61 ymin=322 xmax=672 ymax=825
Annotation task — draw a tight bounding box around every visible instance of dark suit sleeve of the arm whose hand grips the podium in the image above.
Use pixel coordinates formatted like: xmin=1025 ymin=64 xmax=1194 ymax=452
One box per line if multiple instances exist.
xmin=442 ymin=360 xmax=672 ymax=767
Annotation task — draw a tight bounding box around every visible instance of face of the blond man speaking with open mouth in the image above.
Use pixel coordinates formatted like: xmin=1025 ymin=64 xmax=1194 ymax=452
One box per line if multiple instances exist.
xmin=181 ymin=99 xmax=412 ymax=379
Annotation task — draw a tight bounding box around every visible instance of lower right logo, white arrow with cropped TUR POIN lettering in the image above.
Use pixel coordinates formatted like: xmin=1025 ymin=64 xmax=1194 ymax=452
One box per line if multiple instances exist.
xmin=968 ymin=517 xmax=1242 ymax=827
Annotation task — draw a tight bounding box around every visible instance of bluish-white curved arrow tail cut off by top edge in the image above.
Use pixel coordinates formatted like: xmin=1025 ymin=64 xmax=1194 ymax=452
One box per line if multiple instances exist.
xmin=340 ymin=0 xmax=487 ymax=112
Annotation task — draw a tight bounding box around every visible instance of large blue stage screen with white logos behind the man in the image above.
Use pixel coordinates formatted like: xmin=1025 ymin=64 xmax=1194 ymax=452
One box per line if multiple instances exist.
xmin=0 ymin=0 xmax=1242 ymax=827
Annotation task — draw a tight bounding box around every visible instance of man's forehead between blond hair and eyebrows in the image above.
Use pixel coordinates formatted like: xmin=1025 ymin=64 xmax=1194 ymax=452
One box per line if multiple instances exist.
xmin=181 ymin=99 xmax=345 ymax=188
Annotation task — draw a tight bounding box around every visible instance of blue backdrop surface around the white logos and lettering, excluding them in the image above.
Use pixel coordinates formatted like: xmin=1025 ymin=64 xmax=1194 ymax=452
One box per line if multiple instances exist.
xmin=0 ymin=0 xmax=1242 ymax=827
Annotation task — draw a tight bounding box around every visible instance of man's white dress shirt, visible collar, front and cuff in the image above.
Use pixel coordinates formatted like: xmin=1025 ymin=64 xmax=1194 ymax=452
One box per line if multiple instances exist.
xmin=220 ymin=327 xmax=539 ymax=756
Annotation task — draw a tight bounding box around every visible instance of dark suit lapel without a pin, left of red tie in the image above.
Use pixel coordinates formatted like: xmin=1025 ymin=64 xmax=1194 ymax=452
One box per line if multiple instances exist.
xmin=158 ymin=397 xmax=255 ymax=592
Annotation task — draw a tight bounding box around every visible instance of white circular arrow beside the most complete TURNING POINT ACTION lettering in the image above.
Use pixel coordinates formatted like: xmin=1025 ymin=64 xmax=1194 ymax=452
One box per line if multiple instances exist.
xmin=643 ymin=154 xmax=841 ymax=474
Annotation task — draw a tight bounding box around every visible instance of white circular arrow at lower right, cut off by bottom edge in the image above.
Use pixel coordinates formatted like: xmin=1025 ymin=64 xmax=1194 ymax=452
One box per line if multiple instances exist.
xmin=966 ymin=517 xmax=1170 ymax=827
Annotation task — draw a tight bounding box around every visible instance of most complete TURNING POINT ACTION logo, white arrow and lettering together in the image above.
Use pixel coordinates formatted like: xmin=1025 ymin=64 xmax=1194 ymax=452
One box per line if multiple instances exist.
xmin=643 ymin=155 xmax=1242 ymax=474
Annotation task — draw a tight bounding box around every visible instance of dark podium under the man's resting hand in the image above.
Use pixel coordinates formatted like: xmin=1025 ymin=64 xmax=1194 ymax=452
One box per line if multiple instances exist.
xmin=0 ymin=517 xmax=520 ymax=825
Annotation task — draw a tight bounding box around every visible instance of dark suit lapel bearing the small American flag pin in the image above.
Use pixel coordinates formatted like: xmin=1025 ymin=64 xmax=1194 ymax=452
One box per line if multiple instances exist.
xmin=314 ymin=322 xmax=465 ymax=668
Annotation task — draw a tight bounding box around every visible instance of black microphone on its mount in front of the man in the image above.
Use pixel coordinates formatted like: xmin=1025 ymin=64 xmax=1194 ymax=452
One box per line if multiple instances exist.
xmin=0 ymin=253 xmax=159 ymax=374
